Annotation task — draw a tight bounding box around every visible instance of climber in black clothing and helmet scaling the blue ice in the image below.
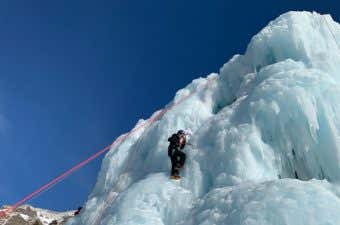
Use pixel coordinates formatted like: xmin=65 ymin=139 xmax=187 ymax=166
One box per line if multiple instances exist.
xmin=168 ymin=130 xmax=186 ymax=179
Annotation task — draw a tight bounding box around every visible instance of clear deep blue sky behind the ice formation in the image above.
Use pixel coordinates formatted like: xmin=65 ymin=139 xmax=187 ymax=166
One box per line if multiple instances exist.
xmin=0 ymin=0 xmax=340 ymax=210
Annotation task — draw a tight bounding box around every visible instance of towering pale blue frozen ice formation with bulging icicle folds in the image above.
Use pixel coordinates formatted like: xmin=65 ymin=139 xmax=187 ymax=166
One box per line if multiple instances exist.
xmin=68 ymin=12 xmax=340 ymax=225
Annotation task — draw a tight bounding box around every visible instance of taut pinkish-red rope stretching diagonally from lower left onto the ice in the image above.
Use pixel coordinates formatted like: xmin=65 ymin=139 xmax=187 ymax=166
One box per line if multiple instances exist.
xmin=0 ymin=77 xmax=216 ymax=218
